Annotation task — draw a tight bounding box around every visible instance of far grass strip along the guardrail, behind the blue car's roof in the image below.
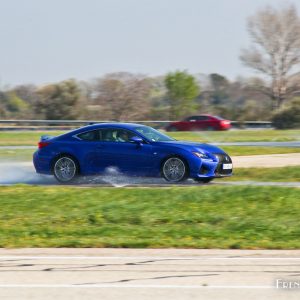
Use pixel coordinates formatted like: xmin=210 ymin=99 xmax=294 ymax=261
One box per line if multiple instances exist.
xmin=0 ymin=130 xmax=300 ymax=146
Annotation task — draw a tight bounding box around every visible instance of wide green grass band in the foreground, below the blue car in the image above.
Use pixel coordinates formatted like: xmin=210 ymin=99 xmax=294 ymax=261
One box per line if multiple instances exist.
xmin=0 ymin=186 xmax=300 ymax=249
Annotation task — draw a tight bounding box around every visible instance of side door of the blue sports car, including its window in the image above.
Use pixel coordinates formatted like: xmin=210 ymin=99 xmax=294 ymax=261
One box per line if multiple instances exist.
xmin=95 ymin=128 xmax=154 ymax=175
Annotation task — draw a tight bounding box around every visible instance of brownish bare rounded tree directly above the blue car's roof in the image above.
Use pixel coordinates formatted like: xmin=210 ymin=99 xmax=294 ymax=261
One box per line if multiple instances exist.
xmin=96 ymin=73 xmax=150 ymax=121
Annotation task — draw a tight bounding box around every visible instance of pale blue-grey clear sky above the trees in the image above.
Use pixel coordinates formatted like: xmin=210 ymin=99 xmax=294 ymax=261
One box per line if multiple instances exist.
xmin=0 ymin=0 xmax=300 ymax=87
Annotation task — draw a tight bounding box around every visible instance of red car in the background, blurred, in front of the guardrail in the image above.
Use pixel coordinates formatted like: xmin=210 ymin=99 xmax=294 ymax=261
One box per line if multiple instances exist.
xmin=166 ymin=115 xmax=231 ymax=131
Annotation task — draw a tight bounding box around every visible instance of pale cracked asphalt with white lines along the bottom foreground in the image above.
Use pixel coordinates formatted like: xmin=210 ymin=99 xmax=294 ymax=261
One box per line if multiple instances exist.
xmin=0 ymin=249 xmax=300 ymax=300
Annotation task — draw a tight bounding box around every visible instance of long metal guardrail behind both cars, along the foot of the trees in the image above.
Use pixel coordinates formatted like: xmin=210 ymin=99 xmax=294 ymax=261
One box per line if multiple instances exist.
xmin=0 ymin=120 xmax=272 ymax=131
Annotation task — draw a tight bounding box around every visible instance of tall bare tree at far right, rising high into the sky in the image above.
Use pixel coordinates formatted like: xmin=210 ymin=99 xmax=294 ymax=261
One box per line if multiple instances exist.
xmin=240 ymin=5 xmax=300 ymax=108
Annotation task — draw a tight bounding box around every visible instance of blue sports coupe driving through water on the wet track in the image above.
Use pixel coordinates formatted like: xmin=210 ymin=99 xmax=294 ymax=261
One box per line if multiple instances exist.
xmin=33 ymin=123 xmax=232 ymax=183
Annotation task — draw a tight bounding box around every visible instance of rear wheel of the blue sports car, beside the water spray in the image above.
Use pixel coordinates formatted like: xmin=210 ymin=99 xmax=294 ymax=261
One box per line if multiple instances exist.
xmin=53 ymin=156 xmax=78 ymax=183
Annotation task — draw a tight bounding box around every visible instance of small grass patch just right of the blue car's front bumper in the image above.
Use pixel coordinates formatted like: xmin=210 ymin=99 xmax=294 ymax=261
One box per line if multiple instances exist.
xmin=217 ymin=166 xmax=300 ymax=182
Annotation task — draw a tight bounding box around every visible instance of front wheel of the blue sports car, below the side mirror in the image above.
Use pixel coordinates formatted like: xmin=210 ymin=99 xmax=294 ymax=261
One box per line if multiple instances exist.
xmin=162 ymin=157 xmax=188 ymax=182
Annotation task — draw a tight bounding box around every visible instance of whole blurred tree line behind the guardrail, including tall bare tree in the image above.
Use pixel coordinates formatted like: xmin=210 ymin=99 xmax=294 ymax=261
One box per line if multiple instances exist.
xmin=0 ymin=5 xmax=300 ymax=123
